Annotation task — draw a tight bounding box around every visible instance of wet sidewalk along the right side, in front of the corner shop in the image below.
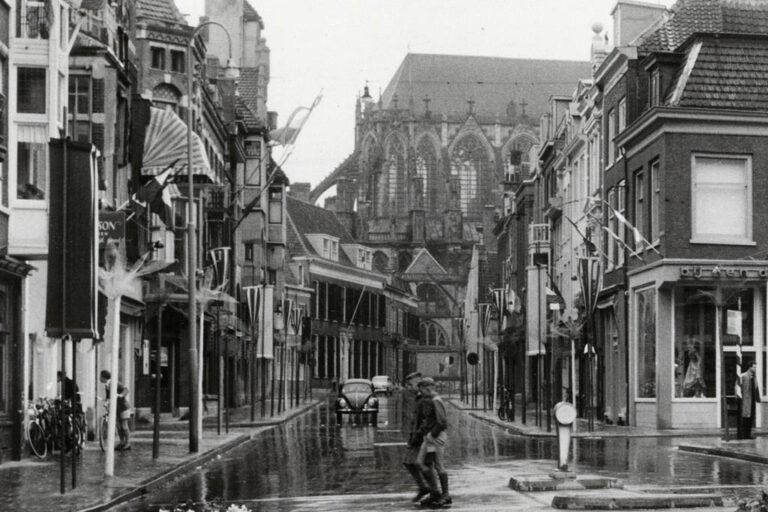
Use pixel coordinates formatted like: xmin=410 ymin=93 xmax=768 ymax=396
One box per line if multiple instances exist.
xmin=448 ymin=398 xmax=768 ymax=440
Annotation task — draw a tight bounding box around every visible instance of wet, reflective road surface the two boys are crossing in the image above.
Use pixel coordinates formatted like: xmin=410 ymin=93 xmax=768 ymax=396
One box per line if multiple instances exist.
xmin=116 ymin=397 xmax=768 ymax=512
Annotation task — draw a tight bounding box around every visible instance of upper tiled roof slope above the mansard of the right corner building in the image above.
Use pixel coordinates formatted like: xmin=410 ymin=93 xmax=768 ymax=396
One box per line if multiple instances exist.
xmin=638 ymin=0 xmax=768 ymax=52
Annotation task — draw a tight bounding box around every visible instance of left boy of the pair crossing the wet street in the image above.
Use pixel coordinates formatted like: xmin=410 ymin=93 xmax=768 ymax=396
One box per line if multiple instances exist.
xmin=402 ymin=372 xmax=432 ymax=503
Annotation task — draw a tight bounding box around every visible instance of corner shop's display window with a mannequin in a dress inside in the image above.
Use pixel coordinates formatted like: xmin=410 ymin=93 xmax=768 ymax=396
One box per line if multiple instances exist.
xmin=673 ymin=288 xmax=717 ymax=398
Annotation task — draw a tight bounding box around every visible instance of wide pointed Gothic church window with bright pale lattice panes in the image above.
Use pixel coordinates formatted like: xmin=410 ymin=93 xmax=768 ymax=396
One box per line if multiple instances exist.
xmin=451 ymin=135 xmax=491 ymax=217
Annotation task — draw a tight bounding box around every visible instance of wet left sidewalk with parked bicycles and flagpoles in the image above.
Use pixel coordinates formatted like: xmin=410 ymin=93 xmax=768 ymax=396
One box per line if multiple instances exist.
xmin=0 ymin=399 xmax=320 ymax=512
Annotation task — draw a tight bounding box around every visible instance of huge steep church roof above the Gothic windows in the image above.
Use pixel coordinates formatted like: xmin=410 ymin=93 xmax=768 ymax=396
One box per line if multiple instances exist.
xmin=382 ymin=53 xmax=592 ymax=117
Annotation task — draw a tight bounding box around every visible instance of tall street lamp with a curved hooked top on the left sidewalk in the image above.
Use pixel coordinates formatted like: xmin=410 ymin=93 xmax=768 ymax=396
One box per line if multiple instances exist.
xmin=186 ymin=21 xmax=237 ymax=452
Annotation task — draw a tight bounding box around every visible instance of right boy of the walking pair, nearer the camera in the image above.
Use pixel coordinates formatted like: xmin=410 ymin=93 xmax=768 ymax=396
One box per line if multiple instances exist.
xmin=417 ymin=377 xmax=453 ymax=508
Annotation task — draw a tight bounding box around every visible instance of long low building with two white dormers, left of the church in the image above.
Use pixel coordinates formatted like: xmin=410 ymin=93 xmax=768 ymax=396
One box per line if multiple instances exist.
xmin=287 ymin=190 xmax=420 ymax=386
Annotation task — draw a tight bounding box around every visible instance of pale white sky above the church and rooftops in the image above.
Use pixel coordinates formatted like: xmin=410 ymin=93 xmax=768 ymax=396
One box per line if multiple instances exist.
xmin=176 ymin=0 xmax=673 ymax=185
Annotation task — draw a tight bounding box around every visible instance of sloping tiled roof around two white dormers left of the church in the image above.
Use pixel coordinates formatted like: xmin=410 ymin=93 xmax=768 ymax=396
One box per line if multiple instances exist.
xmin=286 ymin=196 xmax=355 ymax=265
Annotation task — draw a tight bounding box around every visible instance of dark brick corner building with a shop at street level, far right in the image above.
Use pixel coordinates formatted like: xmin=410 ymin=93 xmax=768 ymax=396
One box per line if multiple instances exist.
xmin=606 ymin=0 xmax=768 ymax=428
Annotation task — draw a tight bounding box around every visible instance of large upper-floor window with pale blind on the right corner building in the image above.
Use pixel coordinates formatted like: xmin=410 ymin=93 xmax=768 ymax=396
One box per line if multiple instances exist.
xmin=691 ymin=155 xmax=752 ymax=243
